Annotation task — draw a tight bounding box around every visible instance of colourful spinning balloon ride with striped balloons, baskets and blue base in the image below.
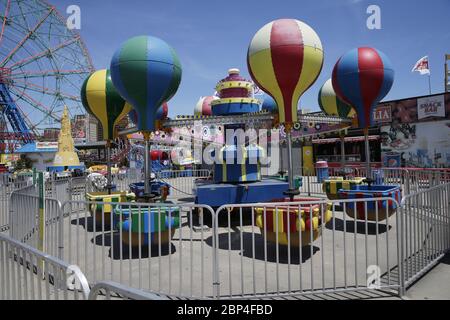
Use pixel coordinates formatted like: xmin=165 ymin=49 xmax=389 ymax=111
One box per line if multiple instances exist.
xmin=74 ymin=19 xmax=400 ymax=246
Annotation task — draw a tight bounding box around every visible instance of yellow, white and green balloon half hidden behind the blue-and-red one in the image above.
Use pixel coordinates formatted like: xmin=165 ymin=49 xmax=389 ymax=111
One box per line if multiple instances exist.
xmin=319 ymin=79 xmax=356 ymax=118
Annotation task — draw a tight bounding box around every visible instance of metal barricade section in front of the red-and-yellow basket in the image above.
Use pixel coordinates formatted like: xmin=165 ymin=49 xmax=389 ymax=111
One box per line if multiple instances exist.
xmin=215 ymin=198 xmax=400 ymax=299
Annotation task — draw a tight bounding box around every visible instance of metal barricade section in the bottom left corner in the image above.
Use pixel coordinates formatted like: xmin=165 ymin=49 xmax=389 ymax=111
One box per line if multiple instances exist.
xmin=0 ymin=234 xmax=89 ymax=300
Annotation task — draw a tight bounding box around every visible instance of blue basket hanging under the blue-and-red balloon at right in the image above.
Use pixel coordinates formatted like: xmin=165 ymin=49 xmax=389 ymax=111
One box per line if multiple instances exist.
xmin=338 ymin=185 xmax=402 ymax=221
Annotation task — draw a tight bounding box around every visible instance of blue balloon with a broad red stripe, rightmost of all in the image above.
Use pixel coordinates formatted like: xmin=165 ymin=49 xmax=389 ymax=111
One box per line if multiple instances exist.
xmin=332 ymin=47 xmax=394 ymax=129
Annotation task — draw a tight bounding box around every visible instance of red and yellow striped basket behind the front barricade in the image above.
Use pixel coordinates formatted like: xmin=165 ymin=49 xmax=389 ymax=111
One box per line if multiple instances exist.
xmin=255 ymin=199 xmax=332 ymax=248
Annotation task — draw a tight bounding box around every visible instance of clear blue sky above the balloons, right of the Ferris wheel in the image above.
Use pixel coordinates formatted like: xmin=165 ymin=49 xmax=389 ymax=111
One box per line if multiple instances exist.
xmin=53 ymin=0 xmax=450 ymax=116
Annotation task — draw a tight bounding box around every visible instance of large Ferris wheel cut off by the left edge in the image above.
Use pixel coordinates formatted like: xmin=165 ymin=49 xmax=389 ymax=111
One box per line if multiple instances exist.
xmin=0 ymin=0 xmax=94 ymax=150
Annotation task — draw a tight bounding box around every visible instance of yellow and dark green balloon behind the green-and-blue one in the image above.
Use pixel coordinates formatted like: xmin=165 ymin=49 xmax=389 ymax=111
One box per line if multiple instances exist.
xmin=81 ymin=70 xmax=132 ymax=140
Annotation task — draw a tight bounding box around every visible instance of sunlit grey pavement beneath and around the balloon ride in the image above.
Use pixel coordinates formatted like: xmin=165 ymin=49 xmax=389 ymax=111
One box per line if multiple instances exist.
xmin=2 ymin=178 xmax=450 ymax=300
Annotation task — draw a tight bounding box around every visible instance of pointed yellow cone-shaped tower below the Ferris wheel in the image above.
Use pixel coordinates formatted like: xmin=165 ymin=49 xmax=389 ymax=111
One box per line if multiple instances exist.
xmin=53 ymin=106 xmax=80 ymax=167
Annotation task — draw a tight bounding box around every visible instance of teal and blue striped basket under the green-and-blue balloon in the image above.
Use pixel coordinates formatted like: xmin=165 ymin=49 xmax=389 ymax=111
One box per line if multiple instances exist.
xmin=113 ymin=206 xmax=180 ymax=247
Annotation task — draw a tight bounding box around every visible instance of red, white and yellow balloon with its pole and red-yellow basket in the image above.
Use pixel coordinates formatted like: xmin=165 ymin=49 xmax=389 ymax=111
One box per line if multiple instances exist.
xmin=247 ymin=19 xmax=331 ymax=247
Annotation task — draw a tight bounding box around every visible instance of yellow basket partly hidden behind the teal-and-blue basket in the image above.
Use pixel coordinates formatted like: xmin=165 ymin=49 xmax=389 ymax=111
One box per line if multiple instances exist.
xmin=86 ymin=191 xmax=136 ymax=227
